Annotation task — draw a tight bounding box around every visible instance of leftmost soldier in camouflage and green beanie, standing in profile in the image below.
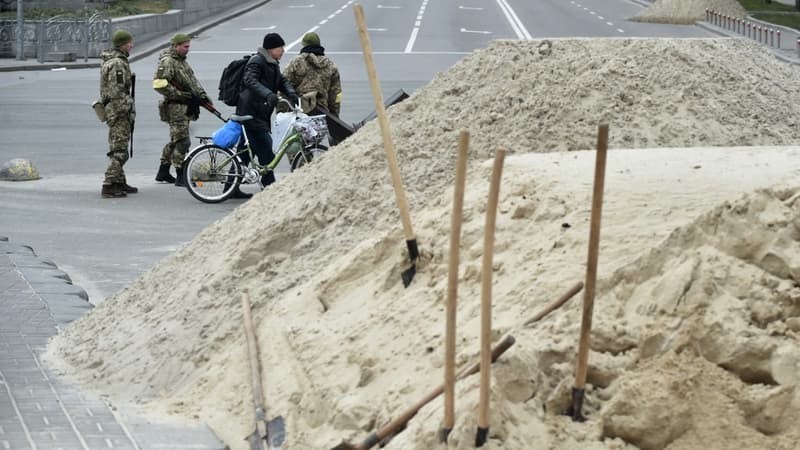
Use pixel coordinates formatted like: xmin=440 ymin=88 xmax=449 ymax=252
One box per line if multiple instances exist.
xmin=100 ymin=30 xmax=139 ymax=198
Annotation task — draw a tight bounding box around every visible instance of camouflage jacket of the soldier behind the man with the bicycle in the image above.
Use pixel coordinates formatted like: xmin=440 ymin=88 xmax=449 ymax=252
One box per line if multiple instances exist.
xmin=283 ymin=45 xmax=342 ymax=116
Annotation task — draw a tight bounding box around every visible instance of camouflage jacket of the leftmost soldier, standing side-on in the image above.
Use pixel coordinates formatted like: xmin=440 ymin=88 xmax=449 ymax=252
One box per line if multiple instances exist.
xmin=100 ymin=48 xmax=136 ymax=123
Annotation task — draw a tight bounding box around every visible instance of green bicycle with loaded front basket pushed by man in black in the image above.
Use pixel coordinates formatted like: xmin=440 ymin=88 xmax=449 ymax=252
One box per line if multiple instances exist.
xmin=183 ymin=99 xmax=328 ymax=203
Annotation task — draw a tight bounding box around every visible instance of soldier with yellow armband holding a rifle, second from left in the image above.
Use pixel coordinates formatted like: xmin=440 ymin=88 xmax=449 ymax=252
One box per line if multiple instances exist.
xmin=153 ymin=33 xmax=212 ymax=186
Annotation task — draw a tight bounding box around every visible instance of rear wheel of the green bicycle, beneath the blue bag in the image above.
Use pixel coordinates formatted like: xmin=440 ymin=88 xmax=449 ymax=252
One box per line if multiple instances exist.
xmin=183 ymin=144 xmax=242 ymax=203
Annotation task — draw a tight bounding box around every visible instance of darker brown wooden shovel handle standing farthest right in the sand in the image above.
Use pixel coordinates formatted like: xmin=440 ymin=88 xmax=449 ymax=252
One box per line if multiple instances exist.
xmin=575 ymin=124 xmax=608 ymax=389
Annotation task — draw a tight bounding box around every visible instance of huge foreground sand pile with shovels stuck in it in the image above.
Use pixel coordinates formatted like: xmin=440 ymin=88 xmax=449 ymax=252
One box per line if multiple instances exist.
xmin=48 ymin=39 xmax=800 ymax=449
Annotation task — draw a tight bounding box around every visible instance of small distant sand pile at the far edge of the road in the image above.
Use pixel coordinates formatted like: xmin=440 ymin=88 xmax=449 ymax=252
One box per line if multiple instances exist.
xmin=630 ymin=0 xmax=747 ymax=24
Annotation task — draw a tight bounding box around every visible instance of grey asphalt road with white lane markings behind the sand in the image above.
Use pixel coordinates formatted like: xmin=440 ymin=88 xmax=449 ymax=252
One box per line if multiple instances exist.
xmin=0 ymin=0 xmax=710 ymax=303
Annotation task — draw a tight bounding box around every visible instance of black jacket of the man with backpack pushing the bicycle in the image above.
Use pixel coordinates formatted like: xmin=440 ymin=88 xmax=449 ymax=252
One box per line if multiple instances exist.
xmin=236 ymin=48 xmax=297 ymax=130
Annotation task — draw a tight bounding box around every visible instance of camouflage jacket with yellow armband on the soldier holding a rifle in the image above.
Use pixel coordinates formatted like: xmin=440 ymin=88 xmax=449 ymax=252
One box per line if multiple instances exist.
xmin=153 ymin=47 xmax=211 ymax=120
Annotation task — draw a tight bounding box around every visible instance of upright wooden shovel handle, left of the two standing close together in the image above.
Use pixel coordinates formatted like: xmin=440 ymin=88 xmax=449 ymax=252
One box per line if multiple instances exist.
xmin=442 ymin=130 xmax=469 ymax=429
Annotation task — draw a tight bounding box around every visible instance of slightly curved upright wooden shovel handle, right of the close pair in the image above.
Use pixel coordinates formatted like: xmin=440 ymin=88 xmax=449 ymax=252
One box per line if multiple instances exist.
xmin=478 ymin=149 xmax=506 ymax=428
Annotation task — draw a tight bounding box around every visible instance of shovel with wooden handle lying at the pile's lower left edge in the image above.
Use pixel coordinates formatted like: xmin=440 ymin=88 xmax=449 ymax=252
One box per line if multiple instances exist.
xmin=242 ymin=292 xmax=286 ymax=450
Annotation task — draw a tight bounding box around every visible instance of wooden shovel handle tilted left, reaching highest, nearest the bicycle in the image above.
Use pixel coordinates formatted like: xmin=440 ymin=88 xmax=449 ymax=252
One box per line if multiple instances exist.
xmin=353 ymin=4 xmax=416 ymax=241
